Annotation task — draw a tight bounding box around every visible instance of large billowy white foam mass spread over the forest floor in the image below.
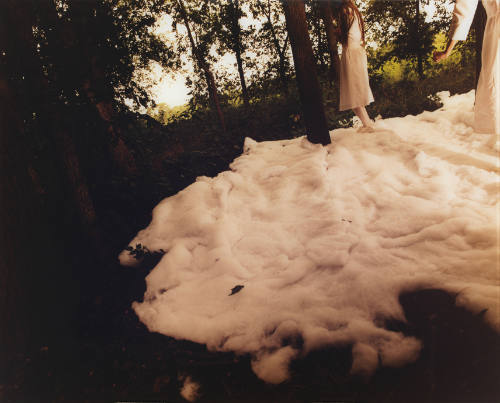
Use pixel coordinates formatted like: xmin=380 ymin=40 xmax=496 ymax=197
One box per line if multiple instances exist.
xmin=120 ymin=92 xmax=500 ymax=383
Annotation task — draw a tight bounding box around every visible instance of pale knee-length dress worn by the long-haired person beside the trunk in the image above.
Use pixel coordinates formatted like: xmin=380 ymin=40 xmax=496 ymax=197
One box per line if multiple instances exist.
xmin=339 ymin=15 xmax=373 ymax=111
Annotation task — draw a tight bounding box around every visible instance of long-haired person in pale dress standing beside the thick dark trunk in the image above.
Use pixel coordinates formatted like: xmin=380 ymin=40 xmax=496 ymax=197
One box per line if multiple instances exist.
xmin=335 ymin=0 xmax=373 ymax=131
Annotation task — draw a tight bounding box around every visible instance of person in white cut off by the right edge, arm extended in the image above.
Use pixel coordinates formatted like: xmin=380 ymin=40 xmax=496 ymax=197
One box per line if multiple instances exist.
xmin=434 ymin=0 xmax=500 ymax=137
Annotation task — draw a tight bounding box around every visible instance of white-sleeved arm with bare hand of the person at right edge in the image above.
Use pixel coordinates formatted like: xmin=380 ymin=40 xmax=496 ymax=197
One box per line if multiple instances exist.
xmin=433 ymin=0 xmax=478 ymax=62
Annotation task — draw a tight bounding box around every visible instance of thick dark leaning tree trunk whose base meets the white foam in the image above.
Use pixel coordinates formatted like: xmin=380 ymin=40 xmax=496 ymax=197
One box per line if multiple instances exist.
xmin=282 ymin=0 xmax=331 ymax=145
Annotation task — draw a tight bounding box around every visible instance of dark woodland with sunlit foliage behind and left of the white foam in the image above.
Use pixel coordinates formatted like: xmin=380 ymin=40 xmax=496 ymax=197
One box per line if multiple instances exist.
xmin=0 ymin=0 xmax=492 ymax=401
